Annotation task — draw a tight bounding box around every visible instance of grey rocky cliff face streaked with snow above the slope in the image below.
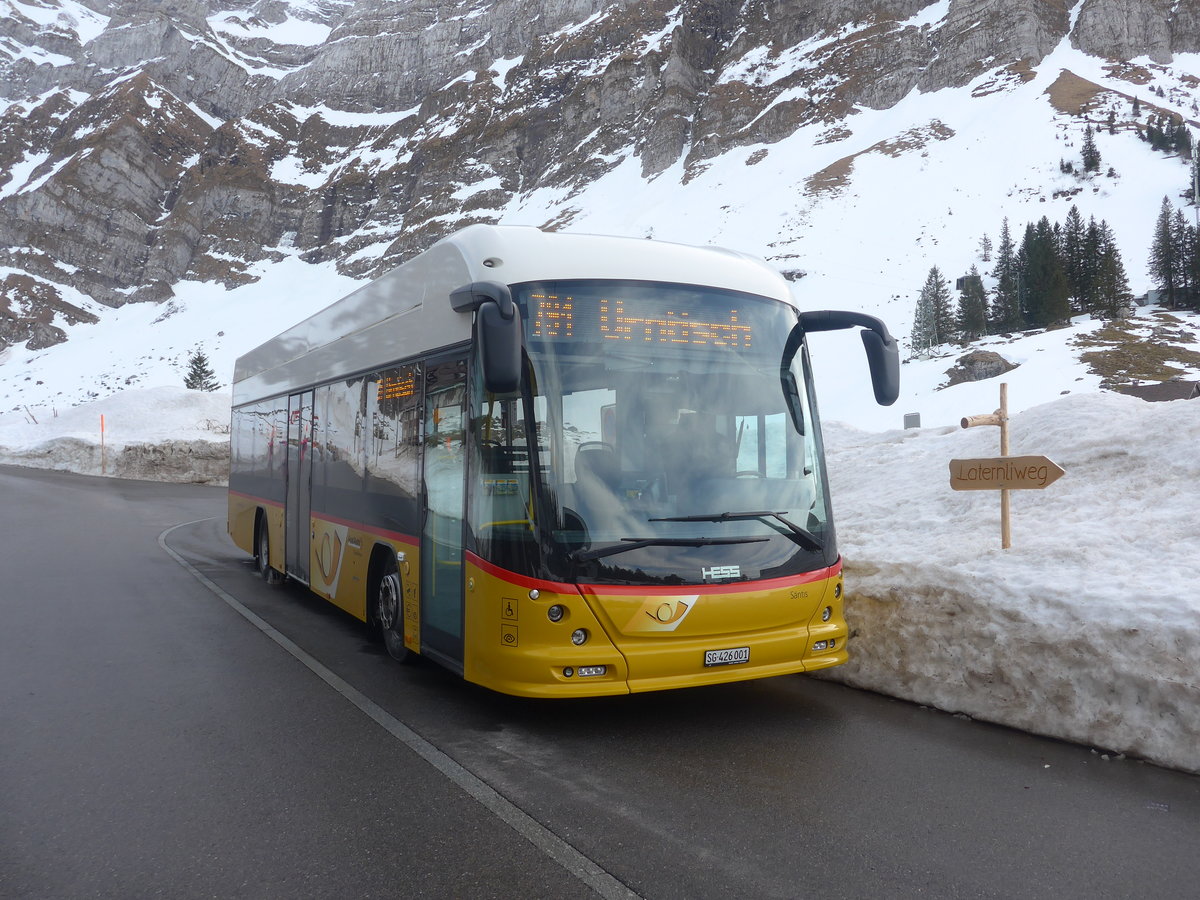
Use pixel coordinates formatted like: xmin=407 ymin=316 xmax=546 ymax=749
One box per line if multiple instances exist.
xmin=0 ymin=0 xmax=1200 ymax=349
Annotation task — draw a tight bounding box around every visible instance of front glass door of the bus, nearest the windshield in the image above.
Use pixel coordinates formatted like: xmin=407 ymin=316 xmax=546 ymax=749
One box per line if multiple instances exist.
xmin=421 ymin=358 xmax=467 ymax=668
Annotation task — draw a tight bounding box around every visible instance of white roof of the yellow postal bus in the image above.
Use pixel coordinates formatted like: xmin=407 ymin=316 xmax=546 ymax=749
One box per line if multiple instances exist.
xmin=233 ymin=224 xmax=792 ymax=406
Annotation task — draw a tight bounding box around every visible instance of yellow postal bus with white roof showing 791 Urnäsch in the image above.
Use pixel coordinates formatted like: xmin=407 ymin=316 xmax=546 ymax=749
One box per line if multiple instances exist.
xmin=228 ymin=226 xmax=899 ymax=697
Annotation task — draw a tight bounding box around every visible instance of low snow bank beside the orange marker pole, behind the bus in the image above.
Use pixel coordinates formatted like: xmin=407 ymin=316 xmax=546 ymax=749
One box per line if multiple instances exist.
xmin=0 ymin=388 xmax=229 ymax=484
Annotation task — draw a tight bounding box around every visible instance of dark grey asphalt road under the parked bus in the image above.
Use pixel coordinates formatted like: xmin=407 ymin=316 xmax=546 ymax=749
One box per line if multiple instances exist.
xmin=0 ymin=468 xmax=1200 ymax=900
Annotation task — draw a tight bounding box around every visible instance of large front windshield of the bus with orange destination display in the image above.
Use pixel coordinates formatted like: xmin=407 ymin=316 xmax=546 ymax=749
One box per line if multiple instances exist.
xmin=470 ymin=281 xmax=836 ymax=584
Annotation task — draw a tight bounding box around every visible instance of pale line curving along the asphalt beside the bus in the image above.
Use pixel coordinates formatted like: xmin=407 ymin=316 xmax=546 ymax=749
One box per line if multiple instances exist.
xmin=166 ymin=516 xmax=641 ymax=900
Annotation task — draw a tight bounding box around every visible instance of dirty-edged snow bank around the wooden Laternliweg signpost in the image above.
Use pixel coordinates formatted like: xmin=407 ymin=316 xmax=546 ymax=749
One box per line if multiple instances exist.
xmin=827 ymin=394 xmax=1200 ymax=772
